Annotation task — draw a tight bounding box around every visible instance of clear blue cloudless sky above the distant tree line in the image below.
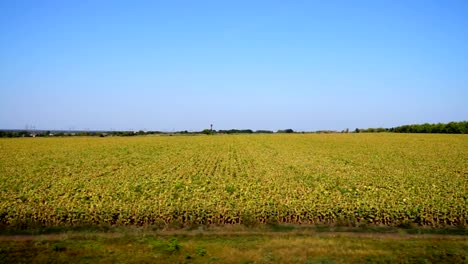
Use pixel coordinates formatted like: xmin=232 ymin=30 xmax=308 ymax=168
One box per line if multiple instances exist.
xmin=0 ymin=0 xmax=468 ymax=131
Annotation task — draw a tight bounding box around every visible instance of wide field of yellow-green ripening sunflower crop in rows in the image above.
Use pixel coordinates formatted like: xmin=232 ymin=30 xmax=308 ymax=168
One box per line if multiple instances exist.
xmin=0 ymin=133 xmax=468 ymax=229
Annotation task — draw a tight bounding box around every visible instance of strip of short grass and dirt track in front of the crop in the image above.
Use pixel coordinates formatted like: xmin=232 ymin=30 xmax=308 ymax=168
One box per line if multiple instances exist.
xmin=0 ymin=226 xmax=468 ymax=263
